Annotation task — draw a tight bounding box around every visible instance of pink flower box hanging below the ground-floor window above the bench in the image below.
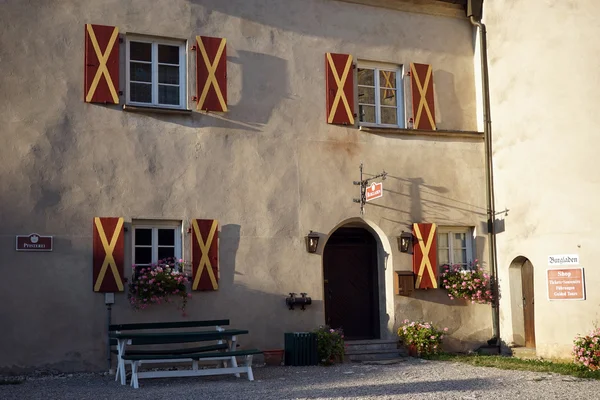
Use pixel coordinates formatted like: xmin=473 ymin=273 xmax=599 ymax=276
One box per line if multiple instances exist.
xmin=128 ymin=258 xmax=192 ymax=314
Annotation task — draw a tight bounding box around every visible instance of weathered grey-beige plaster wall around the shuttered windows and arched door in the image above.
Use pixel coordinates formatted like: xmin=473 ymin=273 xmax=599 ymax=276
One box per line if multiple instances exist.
xmin=0 ymin=0 xmax=491 ymax=372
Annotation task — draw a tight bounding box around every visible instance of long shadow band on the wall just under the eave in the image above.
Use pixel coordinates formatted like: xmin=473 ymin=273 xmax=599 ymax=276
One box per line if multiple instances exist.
xmin=191 ymin=0 xmax=473 ymax=56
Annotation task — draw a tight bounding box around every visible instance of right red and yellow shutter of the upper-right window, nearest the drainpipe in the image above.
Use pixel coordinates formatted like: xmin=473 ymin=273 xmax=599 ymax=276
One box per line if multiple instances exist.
xmin=409 ymin=63 xmax=436 ymax=131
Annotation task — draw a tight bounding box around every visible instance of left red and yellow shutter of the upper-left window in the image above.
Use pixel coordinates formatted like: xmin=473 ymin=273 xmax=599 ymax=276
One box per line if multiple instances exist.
xmin=84 ymin=24 xmax=119 ymax=104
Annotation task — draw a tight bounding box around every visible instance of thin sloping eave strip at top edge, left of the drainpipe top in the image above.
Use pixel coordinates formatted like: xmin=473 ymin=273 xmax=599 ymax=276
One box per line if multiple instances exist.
xmin=336 ymin=0 xmax=467 ymax=19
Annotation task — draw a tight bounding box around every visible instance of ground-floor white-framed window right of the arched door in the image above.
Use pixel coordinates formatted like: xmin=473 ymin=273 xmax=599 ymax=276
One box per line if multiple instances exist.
xmin=437 ymin=227 xmax=473 ymax=270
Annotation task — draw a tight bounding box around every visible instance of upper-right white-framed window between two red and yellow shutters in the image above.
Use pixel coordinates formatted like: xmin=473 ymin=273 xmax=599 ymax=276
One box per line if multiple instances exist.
xmin=357 ymin=61 xmax=404 ymax=128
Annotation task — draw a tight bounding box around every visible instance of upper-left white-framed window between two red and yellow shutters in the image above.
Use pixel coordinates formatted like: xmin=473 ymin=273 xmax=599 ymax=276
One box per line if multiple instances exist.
xmin=125 ymin=35 xmax=187 ymax=109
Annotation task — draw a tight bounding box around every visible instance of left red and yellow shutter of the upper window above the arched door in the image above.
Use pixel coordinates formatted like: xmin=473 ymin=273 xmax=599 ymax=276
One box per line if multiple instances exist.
xmin=325 ymin=53 xmax=354 ymax=125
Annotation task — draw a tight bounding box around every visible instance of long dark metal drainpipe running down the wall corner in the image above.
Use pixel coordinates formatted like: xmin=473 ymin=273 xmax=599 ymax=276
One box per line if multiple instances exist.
xmin=469 ymin=15 xmax=500 ymax=353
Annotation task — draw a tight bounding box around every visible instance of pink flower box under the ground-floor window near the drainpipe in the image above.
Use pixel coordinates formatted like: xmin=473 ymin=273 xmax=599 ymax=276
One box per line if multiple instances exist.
xmin=441 ymin=260 xmax=493 ymax=304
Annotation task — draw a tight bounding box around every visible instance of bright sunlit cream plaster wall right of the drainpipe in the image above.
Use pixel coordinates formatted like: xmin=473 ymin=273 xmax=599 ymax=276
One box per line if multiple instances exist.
xmin=485 ymin=0 xmax=600 ymax=358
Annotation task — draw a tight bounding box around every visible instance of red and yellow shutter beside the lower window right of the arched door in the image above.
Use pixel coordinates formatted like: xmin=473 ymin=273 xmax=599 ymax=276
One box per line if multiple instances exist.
xmin=413 ymin=224 xmax=438 ymax=289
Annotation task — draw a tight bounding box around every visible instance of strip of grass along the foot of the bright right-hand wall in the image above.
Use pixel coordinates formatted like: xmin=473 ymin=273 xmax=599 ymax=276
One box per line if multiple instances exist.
xmin=426 ymin=353 xmax=600 ymax=379
